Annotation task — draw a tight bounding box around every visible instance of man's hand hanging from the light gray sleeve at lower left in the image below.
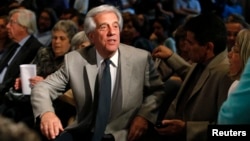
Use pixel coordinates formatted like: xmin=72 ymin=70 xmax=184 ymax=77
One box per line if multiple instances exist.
xmin=40 ymin=112 xmax=64 ymax=140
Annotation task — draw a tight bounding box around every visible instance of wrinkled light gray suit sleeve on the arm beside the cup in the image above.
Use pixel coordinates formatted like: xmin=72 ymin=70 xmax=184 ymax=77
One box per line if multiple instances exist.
xmin=31 ymin=59 xmax=68 ymax=117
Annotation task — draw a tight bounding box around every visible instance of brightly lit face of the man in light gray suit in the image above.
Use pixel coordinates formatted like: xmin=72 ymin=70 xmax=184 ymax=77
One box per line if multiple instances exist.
xmin=89 ymin=12 xmax=120 ymax=58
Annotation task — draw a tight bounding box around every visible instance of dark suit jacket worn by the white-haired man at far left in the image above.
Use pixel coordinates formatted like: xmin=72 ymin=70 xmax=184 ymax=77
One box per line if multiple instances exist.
xmin=0 ymin=35 xmax=42 ymax=98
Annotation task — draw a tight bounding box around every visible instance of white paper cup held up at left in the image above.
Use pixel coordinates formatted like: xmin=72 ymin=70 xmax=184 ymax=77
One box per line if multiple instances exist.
xmin=20 ymin=64 xmax=36 ymax=95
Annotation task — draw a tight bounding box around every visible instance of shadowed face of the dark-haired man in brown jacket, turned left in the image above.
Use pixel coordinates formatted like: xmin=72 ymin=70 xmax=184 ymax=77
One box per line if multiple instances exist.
xmin=186 ymin=31 xmax=208 ymax=63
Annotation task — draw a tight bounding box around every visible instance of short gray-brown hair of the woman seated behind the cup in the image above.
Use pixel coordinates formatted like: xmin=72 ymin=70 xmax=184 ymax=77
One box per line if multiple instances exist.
xmin=52 ymin=20 xmax=78 ymax=41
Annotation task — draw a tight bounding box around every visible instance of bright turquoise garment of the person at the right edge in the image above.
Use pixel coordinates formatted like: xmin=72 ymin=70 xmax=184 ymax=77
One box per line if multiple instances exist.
xmin=218 ymin=59 xmax=250 ymax=125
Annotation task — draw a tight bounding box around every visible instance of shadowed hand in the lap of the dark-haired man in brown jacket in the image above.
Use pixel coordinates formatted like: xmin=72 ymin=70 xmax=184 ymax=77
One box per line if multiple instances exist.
xmin=155 ymin=119 xmax=186 ymax=135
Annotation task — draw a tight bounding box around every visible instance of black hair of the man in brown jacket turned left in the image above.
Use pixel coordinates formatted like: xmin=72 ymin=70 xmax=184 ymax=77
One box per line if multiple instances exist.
xmin=184 ymin=13 xmax=227 ymax=55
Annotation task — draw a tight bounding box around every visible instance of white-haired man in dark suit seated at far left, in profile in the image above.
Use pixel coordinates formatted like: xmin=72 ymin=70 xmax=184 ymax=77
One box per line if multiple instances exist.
xmin=0 ymin=9 xmax=42 ymax=127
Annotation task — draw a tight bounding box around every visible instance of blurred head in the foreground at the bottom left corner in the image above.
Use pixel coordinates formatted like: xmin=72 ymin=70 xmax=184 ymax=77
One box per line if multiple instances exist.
xmin=0 ymin=116 xmax=41 ymax=141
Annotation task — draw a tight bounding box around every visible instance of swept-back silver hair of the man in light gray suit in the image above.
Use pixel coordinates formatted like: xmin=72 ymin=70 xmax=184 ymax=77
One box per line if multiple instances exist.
xmin=84 ymin=4 xmax=123 ymax=35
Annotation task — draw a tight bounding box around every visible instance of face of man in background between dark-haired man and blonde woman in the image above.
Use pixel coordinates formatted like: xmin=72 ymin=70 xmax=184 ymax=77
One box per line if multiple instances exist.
xmin=226 ymin=23 xmax=243 ymax=51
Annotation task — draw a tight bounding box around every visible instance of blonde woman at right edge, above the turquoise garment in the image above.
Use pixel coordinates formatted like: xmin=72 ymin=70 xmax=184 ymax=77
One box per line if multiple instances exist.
xmin=228 ymin=29 xmax=250 ymax=94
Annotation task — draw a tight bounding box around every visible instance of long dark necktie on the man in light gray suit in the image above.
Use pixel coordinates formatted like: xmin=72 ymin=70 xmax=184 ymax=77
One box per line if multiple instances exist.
xmin=92 ymin=59 xmax=111 ymax=141
